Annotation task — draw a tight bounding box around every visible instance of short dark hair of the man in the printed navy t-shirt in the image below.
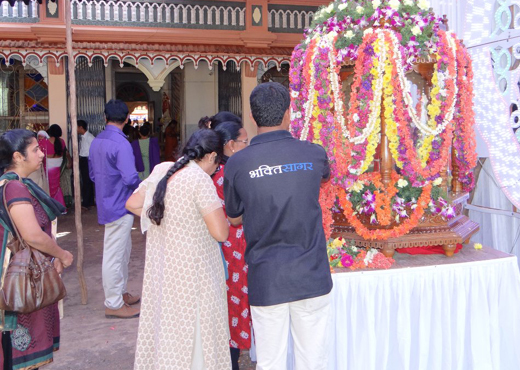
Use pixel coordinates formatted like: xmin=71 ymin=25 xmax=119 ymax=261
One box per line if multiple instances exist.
xmin=249 ymin=82 xmax=291 ymax=127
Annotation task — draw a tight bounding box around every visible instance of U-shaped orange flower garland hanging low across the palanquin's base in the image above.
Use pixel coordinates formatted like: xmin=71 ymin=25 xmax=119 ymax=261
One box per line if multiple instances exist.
xmin=338 ymin=174 xmax=432 ymax=240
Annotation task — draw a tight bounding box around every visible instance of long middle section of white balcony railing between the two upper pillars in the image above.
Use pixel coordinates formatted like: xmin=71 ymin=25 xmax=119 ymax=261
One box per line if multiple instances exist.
xmin=72 ymin=0 xmax=245 ymax=30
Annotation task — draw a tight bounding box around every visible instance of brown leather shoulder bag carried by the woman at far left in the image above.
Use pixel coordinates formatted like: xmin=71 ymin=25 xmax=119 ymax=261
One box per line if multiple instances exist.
xmin=0 ymin=183 xmax=67 ymax=313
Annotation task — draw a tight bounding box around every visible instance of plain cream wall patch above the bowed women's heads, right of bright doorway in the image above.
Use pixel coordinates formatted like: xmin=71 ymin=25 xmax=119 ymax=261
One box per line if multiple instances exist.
xmin=181 ymin=61 xmax=218 ymax=143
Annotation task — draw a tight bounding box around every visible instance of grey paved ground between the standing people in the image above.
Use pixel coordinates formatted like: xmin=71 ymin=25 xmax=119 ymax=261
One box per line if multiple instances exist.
xmin=45 ymin=209 xmax=255 ymax=370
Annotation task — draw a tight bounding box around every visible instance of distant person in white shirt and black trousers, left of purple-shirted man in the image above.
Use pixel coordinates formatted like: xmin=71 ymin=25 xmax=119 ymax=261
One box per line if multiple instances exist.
xmin=78 ymin=120 xmax=94 ymax=211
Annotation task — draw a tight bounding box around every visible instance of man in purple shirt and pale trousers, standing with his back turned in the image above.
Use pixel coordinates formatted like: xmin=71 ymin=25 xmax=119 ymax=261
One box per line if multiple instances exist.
xmin=89 ymin=99 xmax=140 ymax=318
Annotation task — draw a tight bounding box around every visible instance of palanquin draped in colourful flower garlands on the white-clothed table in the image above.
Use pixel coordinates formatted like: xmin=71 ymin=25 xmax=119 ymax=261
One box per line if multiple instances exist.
xmin=290 ymin=0 xmax=478 ymax=255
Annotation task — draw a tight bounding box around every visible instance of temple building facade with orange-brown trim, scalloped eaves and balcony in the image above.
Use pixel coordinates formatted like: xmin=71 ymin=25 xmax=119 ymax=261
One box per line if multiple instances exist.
xmin=0 ymin=0 xmax=328 ymax=152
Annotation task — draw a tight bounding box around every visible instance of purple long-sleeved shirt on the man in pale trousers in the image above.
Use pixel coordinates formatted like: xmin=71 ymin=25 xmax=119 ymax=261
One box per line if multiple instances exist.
xmin=89 ymin=125 xmax=141 ymax=225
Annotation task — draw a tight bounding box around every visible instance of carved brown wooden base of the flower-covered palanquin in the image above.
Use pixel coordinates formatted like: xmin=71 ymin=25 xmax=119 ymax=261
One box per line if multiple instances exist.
xmin=331 ymin=193 xmax=479 ymax=257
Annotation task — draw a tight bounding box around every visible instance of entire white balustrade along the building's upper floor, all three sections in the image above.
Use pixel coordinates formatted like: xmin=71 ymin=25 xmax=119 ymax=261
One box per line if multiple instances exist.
xmin=0 ymin=0 xmax=318 ymax=34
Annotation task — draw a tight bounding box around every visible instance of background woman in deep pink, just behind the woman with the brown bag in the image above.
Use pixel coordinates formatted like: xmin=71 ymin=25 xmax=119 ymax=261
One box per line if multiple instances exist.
xmin=40 ymin=124 xmax=71 ymax=207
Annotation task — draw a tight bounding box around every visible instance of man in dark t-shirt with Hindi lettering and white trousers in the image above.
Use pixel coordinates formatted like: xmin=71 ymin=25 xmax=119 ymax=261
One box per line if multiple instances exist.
xmin=224 ymin=82 xmax=332 ymax=370
